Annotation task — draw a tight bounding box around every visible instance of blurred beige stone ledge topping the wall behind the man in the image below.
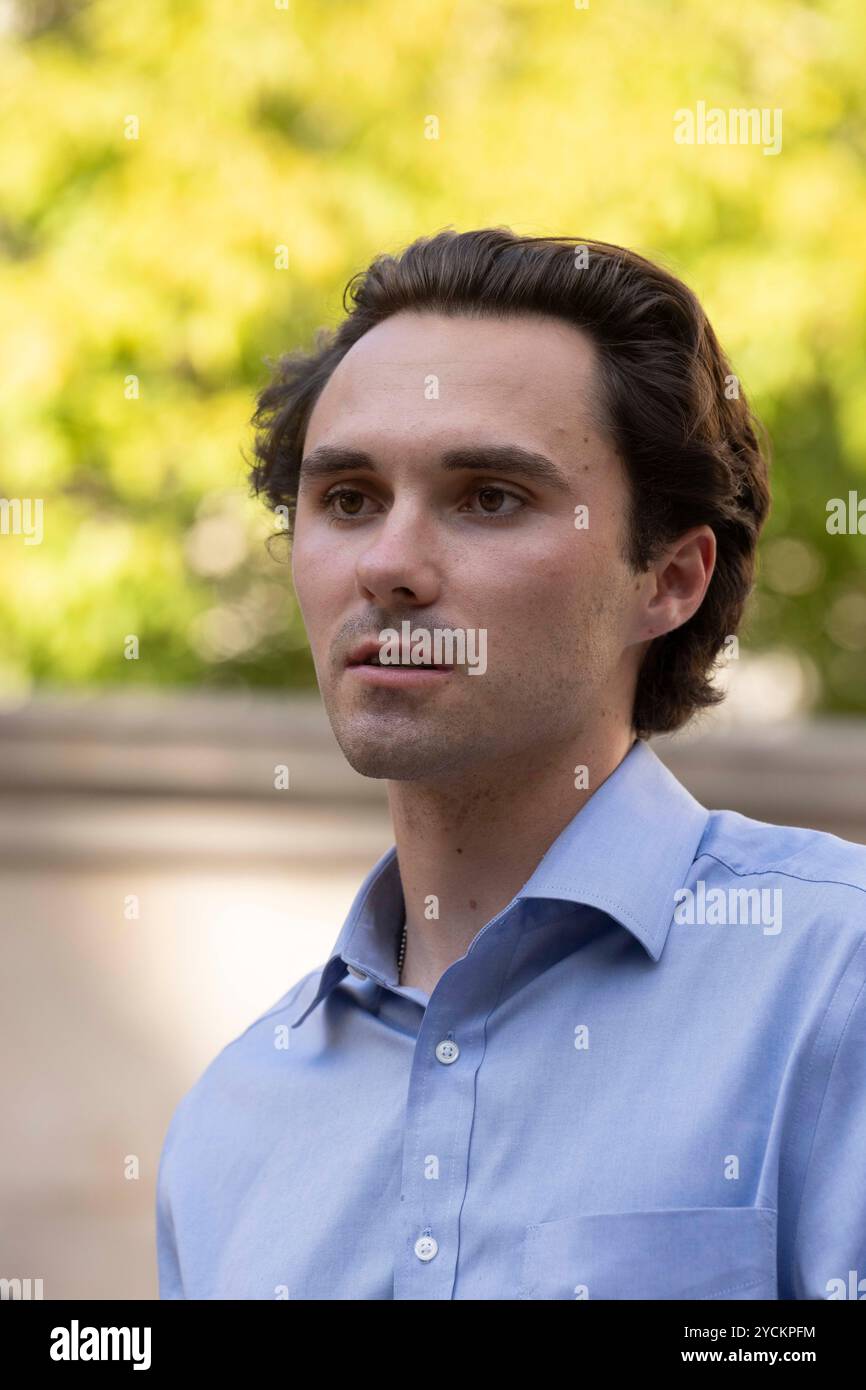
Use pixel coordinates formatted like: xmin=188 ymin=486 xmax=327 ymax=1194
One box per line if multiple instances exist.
xmin=0 ymin=691 xmax=866 ymax=839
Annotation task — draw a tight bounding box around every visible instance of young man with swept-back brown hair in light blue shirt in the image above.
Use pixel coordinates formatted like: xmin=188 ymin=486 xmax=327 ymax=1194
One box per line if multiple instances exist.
xmin=158 ymin=229 xmax=866 ymax=1300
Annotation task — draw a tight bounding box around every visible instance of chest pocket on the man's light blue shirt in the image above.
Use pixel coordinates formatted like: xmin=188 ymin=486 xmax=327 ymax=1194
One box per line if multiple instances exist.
xmin=518 ymin=1207 xmax=777 ymax=1300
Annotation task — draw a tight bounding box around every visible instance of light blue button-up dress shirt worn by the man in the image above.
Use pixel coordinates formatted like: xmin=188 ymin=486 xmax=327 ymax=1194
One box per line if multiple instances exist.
xmin=157 ymin=741 xmax=866 ymax=1300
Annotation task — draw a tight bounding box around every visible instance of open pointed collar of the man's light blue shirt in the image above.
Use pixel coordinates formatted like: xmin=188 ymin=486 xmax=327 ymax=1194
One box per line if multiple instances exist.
xmin=292 ymin=739 xmax=709 ymax=1027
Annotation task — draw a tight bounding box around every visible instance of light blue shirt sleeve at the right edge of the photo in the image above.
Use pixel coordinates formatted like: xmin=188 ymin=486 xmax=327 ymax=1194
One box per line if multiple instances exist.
xmin=792 ymin=942 xmax=866 ymax=1298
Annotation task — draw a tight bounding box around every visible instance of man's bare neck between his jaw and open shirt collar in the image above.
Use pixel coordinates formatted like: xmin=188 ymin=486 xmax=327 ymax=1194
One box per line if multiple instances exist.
xmin=388 ymin=728 xmax=634 ymax=994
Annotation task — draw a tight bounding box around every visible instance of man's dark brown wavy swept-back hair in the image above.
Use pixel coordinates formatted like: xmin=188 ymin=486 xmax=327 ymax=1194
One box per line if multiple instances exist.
xmin=250 ymin=228 xmax=770 ymax=738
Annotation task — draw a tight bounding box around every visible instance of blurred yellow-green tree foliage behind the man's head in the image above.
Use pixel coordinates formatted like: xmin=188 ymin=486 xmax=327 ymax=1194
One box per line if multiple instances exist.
xmin=0 ymin=0 xmax=866 ymax=713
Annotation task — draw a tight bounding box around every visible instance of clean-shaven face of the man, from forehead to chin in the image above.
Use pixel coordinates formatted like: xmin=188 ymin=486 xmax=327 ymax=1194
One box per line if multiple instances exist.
xmin=292 ymin=313 xmax=650 ymax=781
